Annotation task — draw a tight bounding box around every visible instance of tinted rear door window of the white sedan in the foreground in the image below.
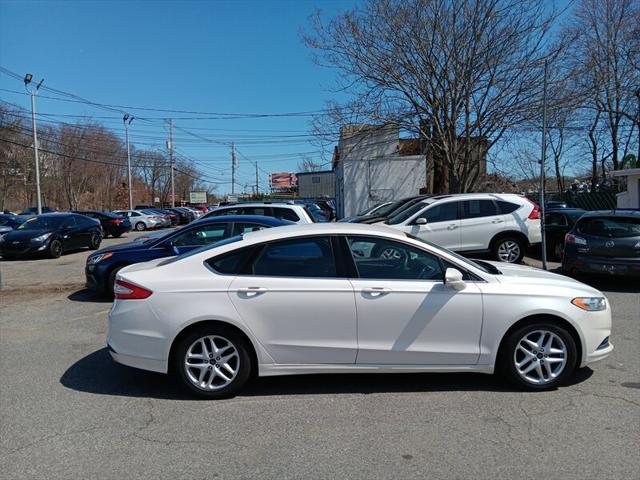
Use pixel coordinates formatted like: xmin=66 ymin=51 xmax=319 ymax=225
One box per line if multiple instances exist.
xmin=252 ymin=238 xmax=336 ymax=277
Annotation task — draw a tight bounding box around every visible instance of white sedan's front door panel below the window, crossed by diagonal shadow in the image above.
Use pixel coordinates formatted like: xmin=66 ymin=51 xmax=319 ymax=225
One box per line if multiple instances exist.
xmin=351 ymin=279 xmax=482 ymax=365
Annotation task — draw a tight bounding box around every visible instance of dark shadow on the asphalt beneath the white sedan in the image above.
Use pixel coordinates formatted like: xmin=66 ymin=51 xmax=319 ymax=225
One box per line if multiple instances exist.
xmin=60 ymin=348 xmax=593 ymax=400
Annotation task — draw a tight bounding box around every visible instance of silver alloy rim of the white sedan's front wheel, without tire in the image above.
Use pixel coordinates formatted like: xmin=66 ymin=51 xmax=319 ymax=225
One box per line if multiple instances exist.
xmin=513 ymin=330 xmax=568 ymax=385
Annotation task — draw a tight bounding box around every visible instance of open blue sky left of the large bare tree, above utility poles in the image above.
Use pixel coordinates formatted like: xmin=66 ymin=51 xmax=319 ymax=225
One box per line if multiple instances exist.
xmin=0 ymin=0 xmax=357 ymax=193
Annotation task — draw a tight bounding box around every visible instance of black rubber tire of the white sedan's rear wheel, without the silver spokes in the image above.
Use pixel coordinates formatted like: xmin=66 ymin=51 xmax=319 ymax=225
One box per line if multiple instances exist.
xmin=172 ymin=324 xmax=252 ymax=400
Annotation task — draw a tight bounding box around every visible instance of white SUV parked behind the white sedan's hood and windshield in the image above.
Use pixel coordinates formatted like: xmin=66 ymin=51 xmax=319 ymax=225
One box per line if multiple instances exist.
xmin=386 ymin=193 xmax=541 ymax=263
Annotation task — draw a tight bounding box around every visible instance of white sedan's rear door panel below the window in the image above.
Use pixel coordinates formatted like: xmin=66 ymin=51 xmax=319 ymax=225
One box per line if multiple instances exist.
xmin=229 ymin=276 xmax=357 ymax=364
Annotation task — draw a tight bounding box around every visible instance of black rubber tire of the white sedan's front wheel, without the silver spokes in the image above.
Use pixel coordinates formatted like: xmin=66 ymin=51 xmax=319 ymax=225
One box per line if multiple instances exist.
xmin=497 ymin=321 xmax=578 ymax=391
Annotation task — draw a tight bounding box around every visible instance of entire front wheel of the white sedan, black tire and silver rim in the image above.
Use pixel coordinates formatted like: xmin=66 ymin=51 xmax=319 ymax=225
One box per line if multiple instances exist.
xmin=499 ymin=322 xmax=577 ymax=390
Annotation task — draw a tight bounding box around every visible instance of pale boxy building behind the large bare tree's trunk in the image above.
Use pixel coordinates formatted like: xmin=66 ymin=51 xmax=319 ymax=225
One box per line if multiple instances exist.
xmin=333 ymin=125 xmax=426 ymax=218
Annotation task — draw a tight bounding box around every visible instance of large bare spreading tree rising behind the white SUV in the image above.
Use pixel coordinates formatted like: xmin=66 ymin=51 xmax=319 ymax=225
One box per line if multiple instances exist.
xmin=305 ymin=0 xmax=555 ymax=192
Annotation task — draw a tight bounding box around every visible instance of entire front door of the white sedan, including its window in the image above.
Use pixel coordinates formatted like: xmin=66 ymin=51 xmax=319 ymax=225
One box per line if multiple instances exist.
xmin=345 ymin=236 xmax=482 ymax=365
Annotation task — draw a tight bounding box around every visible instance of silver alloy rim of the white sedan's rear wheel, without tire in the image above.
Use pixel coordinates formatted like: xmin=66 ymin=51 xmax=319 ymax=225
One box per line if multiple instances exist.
xmin=184 ymin=335 xmax=240 ymax=391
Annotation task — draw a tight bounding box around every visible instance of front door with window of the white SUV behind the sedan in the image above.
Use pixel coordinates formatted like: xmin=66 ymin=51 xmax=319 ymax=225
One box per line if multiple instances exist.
xmin=403 ymin=201 xmax=460 ymax=250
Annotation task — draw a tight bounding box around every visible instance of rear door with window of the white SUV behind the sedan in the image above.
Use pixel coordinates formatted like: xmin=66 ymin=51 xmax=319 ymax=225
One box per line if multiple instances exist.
xmin=460 ymin=198 xmax=513 ymax=251
